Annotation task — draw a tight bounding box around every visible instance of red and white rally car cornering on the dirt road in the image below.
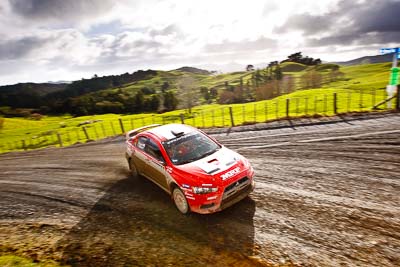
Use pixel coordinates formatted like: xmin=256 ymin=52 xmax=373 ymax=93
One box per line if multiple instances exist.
xmin=126 ymin=124 xmax=254 ymax=214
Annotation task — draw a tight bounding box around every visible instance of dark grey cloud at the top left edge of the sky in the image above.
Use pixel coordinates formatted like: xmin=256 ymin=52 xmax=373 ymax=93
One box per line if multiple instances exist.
xmin=9 ymin=0 xmax=113 ymax=22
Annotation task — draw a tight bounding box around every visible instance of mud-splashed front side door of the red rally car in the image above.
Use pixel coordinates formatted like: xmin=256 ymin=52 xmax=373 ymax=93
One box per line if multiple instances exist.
xmin=144 ymin=138 xmax=168 ymax=191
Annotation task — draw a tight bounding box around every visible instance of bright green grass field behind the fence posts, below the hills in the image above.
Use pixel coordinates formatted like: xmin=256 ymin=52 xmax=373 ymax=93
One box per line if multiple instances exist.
xmin=0 ymin=63 xmax=390 ymax=152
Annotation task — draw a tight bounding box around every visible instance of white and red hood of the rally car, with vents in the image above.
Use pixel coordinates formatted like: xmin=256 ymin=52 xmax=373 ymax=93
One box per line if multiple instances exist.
xmin=178 ymin=147 xmax=242 ymax=180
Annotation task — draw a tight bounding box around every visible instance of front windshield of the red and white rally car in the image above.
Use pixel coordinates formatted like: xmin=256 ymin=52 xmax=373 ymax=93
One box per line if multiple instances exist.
xmin=162 ymin=132 xmax=220 ymax=165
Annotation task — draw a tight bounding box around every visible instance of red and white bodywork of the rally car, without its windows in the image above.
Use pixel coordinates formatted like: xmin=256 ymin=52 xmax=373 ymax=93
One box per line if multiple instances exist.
xmin=126 ymin=124 xmax=254 ymax=214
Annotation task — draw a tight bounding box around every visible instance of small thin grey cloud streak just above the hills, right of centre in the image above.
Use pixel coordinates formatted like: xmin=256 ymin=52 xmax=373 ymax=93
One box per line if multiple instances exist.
xmin=204 ymin=37 xmax=277 ymax=53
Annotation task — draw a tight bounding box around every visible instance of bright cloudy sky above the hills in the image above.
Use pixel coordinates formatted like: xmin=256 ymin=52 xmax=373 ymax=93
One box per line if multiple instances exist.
xmin=0 ymin=0 xmax=400 ymax=85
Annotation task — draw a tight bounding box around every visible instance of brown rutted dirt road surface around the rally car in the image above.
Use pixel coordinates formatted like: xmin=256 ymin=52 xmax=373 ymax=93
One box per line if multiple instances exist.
xmin=0 ymin=114 xmax=400 ymax=266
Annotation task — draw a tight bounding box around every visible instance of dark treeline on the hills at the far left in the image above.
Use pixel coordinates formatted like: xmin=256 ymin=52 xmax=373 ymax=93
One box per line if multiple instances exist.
xmin=0 ymin=70 xmax=165 ymax=115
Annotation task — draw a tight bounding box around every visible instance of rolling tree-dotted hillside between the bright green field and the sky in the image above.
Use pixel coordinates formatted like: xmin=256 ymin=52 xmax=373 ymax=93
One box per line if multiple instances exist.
xmin=0 ymin=62 xmax=391 ymax=116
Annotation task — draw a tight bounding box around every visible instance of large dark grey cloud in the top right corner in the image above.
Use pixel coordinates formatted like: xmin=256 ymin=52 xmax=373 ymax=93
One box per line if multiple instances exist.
xmin=275 ymin=0 xmax=400 ymax=46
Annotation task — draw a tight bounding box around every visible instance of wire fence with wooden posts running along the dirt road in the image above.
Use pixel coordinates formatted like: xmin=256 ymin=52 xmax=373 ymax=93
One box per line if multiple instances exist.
xmin=0 ymin=90 xmax=397 ymax=153
